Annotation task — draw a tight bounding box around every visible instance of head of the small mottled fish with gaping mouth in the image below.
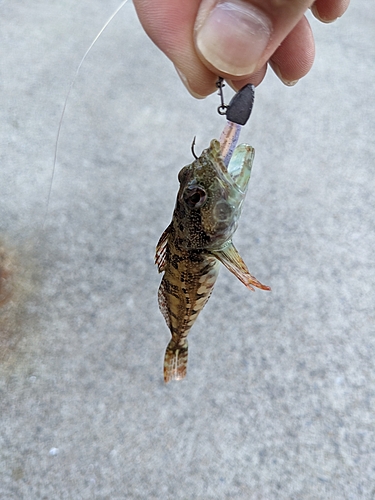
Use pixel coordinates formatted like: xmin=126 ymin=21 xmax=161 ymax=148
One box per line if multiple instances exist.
xmin=174 ymin=139 xmax=254 ymax=250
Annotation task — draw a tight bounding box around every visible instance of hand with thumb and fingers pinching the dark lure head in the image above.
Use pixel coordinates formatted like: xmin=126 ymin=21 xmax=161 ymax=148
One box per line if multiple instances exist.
xmin=134 ymin=0 xmax=350 ymax=98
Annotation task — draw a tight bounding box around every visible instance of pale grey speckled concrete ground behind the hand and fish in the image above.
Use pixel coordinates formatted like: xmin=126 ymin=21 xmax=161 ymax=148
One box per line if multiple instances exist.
xmin=0 ymin=0 xmax=375 ymax=500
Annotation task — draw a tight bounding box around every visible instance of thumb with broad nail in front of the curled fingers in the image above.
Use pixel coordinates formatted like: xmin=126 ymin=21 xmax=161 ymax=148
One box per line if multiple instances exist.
xmin=195 ymin=0 xmax=313 ymax=77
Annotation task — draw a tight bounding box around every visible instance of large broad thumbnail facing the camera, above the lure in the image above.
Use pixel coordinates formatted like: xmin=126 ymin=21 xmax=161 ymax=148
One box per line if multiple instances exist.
xmin=195 ymin=0 xmax=272 ymax=76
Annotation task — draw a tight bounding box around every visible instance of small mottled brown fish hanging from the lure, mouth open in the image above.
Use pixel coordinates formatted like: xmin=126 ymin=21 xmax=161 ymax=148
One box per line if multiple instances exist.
xmin=155 ymin=139 xmax=270 ymax=383
